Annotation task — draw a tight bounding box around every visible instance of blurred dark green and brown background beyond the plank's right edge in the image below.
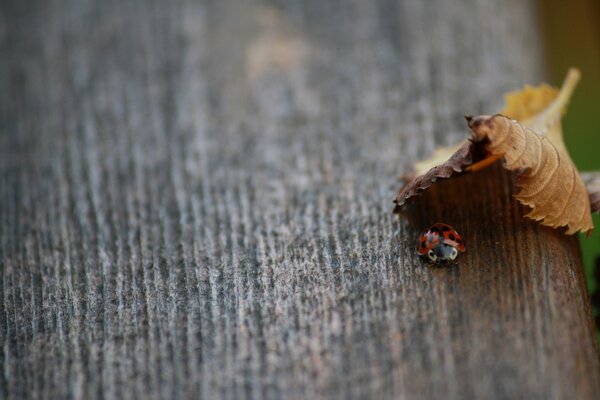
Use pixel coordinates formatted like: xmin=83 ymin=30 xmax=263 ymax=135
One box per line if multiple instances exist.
xmin=538 ymin=0 xmax=600 ymax=328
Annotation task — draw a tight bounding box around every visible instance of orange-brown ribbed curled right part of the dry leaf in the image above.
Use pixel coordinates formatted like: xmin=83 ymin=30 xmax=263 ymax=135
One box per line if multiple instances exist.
xmin=469 ymin=114 xmax=594 ymax=235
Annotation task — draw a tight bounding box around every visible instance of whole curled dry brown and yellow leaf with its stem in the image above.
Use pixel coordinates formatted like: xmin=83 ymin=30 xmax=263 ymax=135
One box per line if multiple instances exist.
xmin=394 ymin=69 xmax=600 ymax=234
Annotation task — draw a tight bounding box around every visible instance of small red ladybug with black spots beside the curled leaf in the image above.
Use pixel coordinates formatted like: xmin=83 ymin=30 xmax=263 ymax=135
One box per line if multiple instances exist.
xmin=418 ymin=222 xmax=465 ymax=263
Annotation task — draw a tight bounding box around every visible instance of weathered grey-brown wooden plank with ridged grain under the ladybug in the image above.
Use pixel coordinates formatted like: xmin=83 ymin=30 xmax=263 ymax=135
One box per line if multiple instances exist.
xmin=0 ymin=0 xmax=600 ymax=399
